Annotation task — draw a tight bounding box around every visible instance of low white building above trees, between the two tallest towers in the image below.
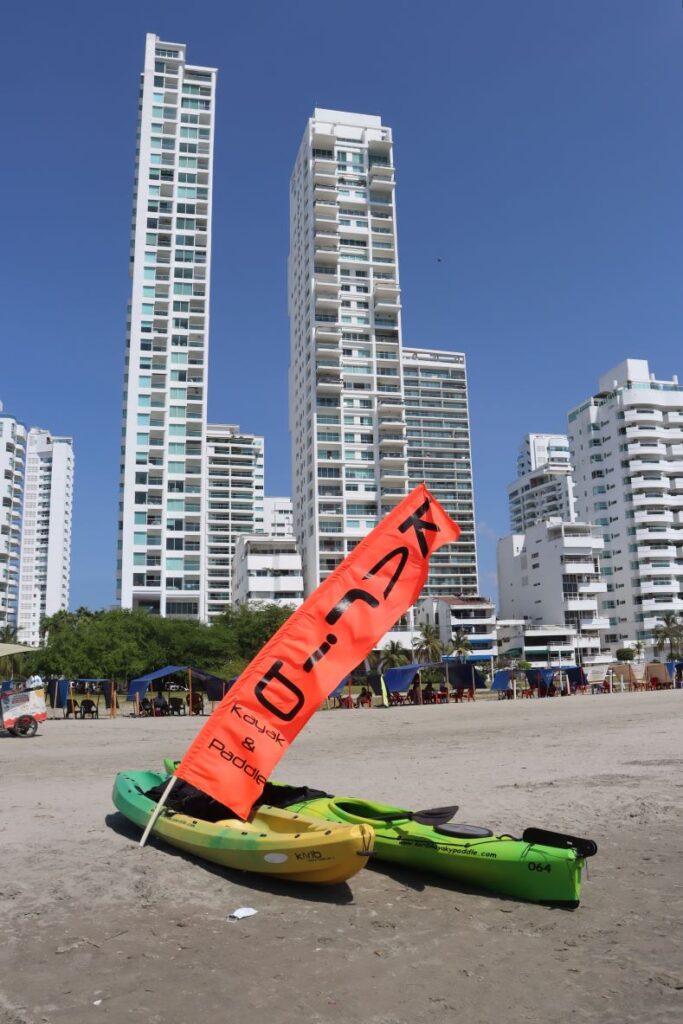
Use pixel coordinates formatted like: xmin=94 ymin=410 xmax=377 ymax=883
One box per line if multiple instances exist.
xmin=232 ymin=536 xmax=303 ymax=607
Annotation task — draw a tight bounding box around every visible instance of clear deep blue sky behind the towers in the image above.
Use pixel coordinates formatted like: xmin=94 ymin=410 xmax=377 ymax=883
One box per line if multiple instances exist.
xmin=0 ymin=0 xmax=683 ymax=606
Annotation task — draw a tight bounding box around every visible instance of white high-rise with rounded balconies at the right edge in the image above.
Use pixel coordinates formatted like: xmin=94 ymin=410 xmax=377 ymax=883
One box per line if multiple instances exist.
xmin=568 ymin=359 xmax=683 ymax=647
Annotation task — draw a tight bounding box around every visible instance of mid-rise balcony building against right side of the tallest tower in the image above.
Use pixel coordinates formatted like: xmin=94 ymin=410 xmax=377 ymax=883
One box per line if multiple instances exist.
xmin=206 ymin=424 xmax=264 ymax=622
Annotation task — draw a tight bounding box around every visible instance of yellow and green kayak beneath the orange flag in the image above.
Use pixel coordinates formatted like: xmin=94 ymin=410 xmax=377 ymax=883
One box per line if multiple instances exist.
xmin=113 ymin=771 xmax=375 ymax=885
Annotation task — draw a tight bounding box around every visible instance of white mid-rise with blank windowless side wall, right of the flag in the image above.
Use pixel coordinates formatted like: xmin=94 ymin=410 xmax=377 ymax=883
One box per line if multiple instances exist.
xmin=498 ymin=519 xmax=609 ymax=665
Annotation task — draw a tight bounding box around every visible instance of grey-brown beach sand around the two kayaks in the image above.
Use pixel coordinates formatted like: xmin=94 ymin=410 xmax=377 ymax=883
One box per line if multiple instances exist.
xmin=0 ymin=691 xmax=683 ymax=1024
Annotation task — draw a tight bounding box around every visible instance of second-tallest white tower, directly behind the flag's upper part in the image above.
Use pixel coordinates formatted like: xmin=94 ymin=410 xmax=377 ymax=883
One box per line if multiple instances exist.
xmin=288 ymin=109 xmax=408 ymax=594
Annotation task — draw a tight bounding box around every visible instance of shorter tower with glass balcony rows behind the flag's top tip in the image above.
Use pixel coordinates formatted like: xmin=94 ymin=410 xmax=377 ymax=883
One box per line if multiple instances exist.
xmin=401 ymin=348 xmax=478 ymax=597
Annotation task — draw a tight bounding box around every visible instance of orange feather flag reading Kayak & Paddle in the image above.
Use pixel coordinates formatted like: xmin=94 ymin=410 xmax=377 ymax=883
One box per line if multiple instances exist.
xmin=175 ymin=483 xmax=460 ymax=818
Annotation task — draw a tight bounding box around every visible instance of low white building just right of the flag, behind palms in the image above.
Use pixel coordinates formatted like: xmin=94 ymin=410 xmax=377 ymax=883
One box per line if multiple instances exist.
xmin=416 ymin=596 xmax=498 ymax=662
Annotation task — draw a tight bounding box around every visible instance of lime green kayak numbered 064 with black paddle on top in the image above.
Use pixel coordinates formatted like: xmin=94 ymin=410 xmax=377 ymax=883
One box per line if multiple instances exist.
xmin=280 ymin=797 xmax=585 ymax=906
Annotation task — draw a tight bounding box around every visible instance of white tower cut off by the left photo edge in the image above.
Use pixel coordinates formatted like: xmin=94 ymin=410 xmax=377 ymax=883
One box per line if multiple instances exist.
xmin=0 ymin=402 xmax=27 ymax=629
